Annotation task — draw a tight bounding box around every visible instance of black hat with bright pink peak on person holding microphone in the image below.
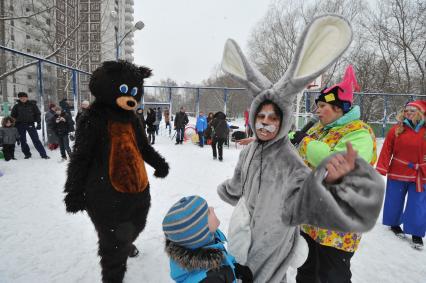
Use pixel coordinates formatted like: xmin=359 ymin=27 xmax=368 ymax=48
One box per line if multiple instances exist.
xmin=315 ymin=65 xmax=360 ymax=113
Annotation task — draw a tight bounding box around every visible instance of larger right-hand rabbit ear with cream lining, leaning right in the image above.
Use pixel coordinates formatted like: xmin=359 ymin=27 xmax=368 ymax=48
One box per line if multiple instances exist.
xmin=274 ymin=15 xmax=352 ymax=91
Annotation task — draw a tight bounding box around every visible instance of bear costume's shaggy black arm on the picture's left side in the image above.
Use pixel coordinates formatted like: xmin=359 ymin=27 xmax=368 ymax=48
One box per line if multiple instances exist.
xmin=64 ymin=115 xmax=100 ymax=213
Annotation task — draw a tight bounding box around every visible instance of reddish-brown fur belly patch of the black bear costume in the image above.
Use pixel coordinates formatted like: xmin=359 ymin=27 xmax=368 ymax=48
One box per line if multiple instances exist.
xmin=108 ymin=122 xmax=148 ymax=193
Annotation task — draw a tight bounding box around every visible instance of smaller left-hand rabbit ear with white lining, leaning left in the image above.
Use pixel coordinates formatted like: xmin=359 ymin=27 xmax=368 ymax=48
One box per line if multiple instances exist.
xmin=222 ymin=39 xmax=272 ymax=96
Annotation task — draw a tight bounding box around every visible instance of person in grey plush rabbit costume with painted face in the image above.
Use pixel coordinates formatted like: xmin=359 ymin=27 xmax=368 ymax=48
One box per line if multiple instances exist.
xmin=218 ymin=15 xmax=384 ymax=282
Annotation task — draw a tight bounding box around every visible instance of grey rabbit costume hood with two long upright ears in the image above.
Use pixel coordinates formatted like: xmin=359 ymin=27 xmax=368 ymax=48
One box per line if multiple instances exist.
xmin=222 ymin=15 xmax=352 ymax=143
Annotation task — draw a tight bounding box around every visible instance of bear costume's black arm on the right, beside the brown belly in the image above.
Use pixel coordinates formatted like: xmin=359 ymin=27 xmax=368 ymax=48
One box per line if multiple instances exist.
xmin=133 ymin=118 xmax=169 ymax=178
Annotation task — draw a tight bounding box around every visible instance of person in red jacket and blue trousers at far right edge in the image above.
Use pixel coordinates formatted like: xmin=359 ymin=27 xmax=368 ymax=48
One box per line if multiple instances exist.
xmin=376 ymin=100 xmax=426 ymax=249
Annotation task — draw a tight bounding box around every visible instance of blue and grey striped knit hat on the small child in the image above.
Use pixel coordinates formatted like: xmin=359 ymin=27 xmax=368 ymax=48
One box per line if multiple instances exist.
xmin=163 ymin=196 xmax=214 ymax=249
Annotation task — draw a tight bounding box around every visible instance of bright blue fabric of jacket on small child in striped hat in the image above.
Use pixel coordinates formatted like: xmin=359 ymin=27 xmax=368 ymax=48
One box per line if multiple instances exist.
xmin=170 ymin=229 xmax=236 ymax=283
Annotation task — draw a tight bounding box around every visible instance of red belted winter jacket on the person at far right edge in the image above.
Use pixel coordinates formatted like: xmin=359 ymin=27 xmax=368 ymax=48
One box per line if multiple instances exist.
xmin=376 ymin=125 xmax=426 ymax=192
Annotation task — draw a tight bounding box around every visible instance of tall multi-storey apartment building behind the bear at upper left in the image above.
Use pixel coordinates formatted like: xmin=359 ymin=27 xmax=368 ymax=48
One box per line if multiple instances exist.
xmin=0 ymin=0 xmax=134 ymax=104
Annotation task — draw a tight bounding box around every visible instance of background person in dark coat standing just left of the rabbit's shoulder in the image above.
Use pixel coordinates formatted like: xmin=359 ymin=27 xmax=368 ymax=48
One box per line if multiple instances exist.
xmin=206 ymin=111 xmax=229 ymax=161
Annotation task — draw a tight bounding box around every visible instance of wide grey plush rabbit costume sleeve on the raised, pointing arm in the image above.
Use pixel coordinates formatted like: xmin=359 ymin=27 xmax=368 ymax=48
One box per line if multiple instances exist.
xmin=282 ymin=155 xmax=385 ymax=232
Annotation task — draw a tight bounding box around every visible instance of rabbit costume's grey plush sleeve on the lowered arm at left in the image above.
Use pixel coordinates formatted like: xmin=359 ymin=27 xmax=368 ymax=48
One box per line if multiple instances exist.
xmin=217 ymin=145 xmax=252 ymax=206
